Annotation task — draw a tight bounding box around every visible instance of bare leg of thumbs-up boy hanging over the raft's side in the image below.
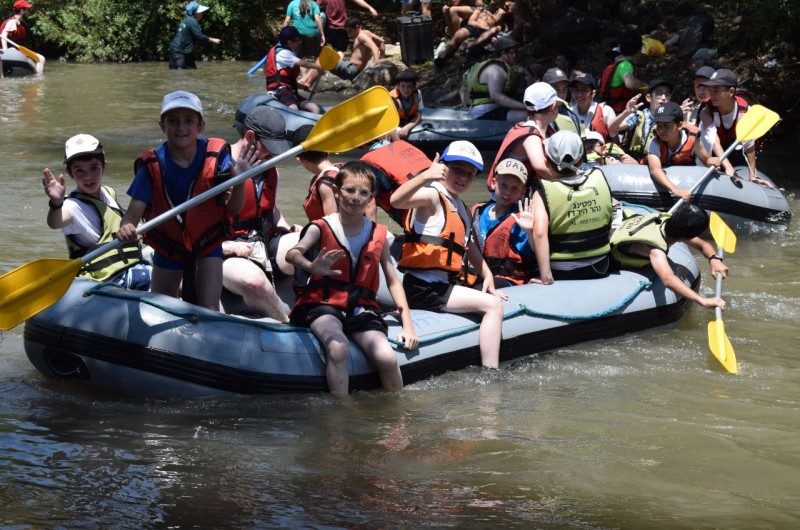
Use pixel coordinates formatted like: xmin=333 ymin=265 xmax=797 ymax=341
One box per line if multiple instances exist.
xmin=442 ymin=285 xmax=503 ymax=368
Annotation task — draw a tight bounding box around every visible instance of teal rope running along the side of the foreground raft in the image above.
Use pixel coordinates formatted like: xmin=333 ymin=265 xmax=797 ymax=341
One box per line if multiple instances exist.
xmin=84 ymin=280 xmax=653 ymax=346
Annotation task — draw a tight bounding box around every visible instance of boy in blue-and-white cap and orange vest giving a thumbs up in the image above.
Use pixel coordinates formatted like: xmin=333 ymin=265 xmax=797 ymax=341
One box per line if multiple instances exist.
xmin=391 ymin=140 xmax=507 ymax=368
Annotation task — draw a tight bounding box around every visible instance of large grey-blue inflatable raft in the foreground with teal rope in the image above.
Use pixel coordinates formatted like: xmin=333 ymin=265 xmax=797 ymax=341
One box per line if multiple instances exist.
xmin=24 ymin=243 xmax=700 ymax=398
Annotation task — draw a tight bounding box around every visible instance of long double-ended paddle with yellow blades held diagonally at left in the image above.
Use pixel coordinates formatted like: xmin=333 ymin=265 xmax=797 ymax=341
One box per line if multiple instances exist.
xmin=0 ymin=87 xmax=400 ymax=330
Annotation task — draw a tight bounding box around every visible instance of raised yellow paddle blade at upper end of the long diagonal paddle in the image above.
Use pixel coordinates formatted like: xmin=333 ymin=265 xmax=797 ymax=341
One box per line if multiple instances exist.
xmin=302 ymin=86 xmax=400 ymax=153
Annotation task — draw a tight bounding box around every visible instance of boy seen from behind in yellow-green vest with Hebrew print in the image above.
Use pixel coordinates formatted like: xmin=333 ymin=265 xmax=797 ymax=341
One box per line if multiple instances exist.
xmin=533 ymin=131 xmax=612 ymax=284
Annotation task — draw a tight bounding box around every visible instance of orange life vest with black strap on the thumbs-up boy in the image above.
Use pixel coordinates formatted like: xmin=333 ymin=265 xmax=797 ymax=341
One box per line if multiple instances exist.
xmin=397 ymin=185 xmax=470 ymax=276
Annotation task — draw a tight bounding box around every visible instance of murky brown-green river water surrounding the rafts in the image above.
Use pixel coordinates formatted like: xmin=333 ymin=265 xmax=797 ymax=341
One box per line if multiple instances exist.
xmin=0 ymin=61 xmax=800 ymax=529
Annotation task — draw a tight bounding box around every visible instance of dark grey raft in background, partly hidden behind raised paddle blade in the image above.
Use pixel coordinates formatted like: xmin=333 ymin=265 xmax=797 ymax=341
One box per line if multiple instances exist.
xmin=239 ymin=92 xmax=513 ymax=156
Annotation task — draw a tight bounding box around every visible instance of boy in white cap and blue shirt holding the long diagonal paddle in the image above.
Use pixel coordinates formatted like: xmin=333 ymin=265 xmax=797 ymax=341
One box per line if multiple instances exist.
xmin=117 ymin=90 xmax=255 ymax=311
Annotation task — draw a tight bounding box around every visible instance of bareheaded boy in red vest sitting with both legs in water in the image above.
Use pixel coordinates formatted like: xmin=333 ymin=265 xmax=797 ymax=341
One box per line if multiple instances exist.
xmin=286 ymin=161 xmax=419 ymax=394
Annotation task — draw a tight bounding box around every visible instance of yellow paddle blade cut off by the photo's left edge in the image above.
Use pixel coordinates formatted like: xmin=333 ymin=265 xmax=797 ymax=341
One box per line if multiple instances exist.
xmin=0 ymin=259 xmax=83 ymax=330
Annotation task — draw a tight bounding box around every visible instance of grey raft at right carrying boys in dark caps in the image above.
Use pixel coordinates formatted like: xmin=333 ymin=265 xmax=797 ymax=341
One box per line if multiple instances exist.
xmin=603 ymin=164 xmax=792 ymax=226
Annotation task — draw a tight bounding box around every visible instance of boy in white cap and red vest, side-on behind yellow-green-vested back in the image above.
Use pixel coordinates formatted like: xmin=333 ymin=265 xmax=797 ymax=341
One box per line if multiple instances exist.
xmin=486 ymin=81 xmax=567 ymax=190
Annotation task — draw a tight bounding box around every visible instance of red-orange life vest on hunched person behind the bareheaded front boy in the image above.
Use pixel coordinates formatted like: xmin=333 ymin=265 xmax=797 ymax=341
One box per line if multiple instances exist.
xmin=361 ymin=140 xmax=431 ymax=224
